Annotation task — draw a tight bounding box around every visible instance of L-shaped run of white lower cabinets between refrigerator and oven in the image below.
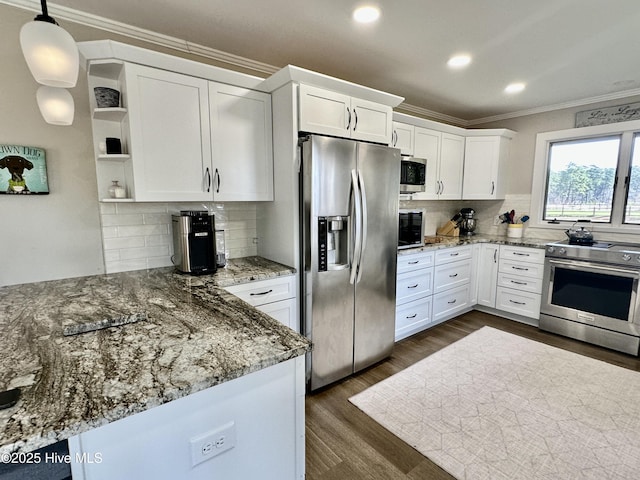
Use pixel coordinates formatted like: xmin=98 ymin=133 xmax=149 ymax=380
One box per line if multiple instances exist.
xmin=396 ymin=243 xmax=545 ymax=341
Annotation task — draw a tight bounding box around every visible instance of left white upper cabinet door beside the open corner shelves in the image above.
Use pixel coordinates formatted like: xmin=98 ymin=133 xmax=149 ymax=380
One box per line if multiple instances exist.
xmin=125 ymin=63 xmax=212 ymax=201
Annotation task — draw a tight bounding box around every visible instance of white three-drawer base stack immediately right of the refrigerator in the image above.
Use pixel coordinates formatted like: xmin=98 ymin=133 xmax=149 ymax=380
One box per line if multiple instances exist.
xmin=395 ymin=251 xmax=435 ymax=341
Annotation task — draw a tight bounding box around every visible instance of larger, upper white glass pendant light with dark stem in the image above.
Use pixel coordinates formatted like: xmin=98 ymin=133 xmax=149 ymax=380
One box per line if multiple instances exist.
xmin=20 ymin=0 xmax=79 ymax=88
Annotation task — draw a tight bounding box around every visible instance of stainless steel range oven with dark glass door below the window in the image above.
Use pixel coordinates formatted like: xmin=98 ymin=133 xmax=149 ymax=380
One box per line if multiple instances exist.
xmin=540 ymin=242 xmax=640 ymax=355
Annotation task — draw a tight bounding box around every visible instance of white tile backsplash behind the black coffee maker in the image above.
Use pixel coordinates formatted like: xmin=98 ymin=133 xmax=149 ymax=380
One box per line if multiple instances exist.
xmin=100 ymin=202 xmax=258 ymax=273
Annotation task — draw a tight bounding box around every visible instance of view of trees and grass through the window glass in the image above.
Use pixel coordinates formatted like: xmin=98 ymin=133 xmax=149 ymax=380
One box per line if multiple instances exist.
xmin=544 ymin=136 xmax=620 ymax=222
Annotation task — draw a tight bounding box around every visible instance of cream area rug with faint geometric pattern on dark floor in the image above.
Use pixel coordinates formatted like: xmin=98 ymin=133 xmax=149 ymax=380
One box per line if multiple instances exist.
xmin=349 ymin=327 xmax=640 ymax=480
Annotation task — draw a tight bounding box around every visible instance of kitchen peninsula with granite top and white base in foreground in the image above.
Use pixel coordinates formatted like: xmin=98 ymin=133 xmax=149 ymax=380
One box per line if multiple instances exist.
xmin=0 ymin=257 xmax=310 ymax=479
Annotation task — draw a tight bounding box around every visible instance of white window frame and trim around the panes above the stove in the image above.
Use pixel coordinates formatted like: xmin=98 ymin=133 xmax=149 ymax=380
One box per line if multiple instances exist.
xmin=531 ymin=120 xmax=640 ymax=233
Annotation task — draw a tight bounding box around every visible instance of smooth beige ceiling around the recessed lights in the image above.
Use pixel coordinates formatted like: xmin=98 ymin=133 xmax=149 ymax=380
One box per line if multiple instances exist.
xmin=15 ymin=0 xmax=640 ymax=124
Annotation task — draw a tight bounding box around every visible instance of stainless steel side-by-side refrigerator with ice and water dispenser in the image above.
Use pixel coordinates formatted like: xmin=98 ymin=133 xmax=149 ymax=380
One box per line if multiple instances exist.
xmin=300 ymin=135 xmax=400 ymax=390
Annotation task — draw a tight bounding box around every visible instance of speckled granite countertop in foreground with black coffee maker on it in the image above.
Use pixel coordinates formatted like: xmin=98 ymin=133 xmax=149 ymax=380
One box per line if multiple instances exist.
xmin=0 ymin=257 xmax=310 ymax=453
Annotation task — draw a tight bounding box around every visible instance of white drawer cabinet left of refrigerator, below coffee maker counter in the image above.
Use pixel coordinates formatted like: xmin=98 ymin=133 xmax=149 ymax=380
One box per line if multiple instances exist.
xmin=225 ymin=275 xmax=300 ymax=332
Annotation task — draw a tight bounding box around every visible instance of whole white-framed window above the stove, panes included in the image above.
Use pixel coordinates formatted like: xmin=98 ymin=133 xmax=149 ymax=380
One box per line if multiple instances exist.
xmin=532 ymin=121 xmax=640 ymax=231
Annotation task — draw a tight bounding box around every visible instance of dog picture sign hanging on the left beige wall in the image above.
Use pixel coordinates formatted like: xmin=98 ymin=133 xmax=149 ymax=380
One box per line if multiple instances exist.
xmin=0 ymin=145 xmax=49 ymax=195
